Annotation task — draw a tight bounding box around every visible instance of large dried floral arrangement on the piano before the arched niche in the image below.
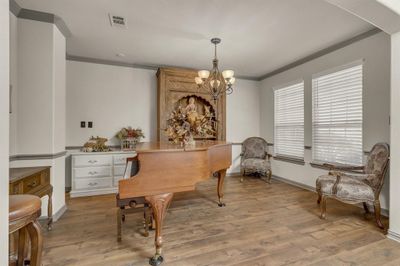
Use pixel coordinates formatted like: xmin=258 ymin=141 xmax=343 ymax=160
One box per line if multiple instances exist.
xmin=165 ymin=106 xmax=215 ymax=145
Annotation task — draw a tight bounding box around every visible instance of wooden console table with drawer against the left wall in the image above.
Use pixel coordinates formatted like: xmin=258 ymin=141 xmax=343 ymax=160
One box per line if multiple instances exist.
xmin=10 ymin=166 xmax=53 ymax=230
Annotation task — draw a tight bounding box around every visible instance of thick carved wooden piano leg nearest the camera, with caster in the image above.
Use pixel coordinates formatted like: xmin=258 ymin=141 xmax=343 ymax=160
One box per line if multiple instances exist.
xmin=145 ymin=193 xmax=174 ymax=266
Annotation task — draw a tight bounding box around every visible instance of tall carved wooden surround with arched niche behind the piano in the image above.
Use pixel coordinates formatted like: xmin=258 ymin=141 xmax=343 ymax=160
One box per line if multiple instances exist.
xmin=157 ymin=68 xmax=226 ymax=141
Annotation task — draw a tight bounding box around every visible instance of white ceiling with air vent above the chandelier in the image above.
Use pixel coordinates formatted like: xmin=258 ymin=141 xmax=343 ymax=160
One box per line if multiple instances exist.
xmin=17 ymin=0 xmax=373 ymax=77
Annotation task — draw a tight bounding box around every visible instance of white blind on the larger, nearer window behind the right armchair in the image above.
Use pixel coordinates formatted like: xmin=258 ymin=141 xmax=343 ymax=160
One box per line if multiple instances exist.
xmin=312 ymin=63 xmax=363 ymax=165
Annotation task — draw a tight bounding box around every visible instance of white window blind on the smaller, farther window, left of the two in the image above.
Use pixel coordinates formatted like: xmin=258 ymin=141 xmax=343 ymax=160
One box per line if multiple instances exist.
xmin=274 ymin=81 xmax=304 ymax=158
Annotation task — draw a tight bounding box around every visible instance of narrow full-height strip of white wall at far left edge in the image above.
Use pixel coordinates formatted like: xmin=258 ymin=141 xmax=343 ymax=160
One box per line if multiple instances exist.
xmin=0 ymin=0 xmax=10 ymax=265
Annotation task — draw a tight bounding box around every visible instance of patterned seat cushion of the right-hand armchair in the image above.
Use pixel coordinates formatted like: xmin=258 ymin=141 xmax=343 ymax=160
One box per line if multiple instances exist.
xmin=317 ymin=175 xmax=375 ymax=201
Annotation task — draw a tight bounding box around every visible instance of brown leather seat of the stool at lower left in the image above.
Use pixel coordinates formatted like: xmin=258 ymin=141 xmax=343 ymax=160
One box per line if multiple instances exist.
xmin=8 ymin=195 xmax=42 ymax=222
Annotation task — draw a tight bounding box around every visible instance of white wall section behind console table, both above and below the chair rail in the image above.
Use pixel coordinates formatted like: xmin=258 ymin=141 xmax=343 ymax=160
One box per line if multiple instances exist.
xmin=10 ymin=18 xmax=66 ymax=215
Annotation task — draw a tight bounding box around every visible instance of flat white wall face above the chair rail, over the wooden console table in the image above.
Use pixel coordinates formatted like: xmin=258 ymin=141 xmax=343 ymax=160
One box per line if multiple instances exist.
xmin=17 ymin=19 xmax=54 ymax=154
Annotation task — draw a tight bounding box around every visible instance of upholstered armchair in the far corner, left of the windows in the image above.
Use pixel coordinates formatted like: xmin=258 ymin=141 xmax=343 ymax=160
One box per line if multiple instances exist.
xmin=240 ymin=137 xmax=272 ymax=183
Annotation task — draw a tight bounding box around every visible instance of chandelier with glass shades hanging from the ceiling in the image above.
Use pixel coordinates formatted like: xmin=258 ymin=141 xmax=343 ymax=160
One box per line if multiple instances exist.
xmin=194 ymin=38 xmax=235 ymax=101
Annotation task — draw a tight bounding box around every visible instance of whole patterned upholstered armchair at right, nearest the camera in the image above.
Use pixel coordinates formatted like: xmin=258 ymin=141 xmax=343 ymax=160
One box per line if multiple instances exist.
xmin=316 ymin=143 xmax=389 ymax=229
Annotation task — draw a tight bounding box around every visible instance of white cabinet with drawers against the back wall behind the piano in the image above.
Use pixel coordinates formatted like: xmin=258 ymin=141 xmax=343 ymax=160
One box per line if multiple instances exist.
xmin=71 ymin=151 xmax=136 ymax=197
